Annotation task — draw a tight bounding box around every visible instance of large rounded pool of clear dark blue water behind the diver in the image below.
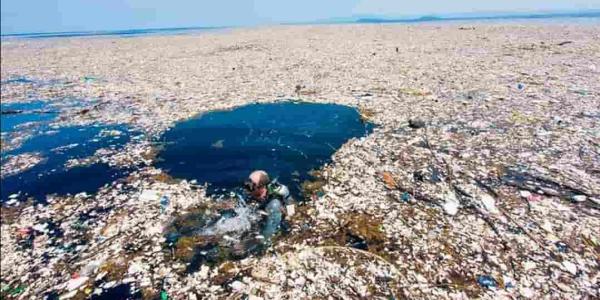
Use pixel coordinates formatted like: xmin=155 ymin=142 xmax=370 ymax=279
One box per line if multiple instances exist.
xmin=156 ymin=101 xmax=373 ymax=197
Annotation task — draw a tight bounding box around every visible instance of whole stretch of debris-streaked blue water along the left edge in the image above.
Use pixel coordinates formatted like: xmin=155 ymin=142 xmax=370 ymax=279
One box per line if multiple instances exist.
xmin=0 ymin=100 xmax=130 ymax=202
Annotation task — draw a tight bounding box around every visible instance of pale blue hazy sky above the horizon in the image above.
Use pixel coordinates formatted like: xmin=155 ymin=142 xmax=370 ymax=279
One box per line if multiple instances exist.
xmin=0 ymin=0 xmax=600 ymax=34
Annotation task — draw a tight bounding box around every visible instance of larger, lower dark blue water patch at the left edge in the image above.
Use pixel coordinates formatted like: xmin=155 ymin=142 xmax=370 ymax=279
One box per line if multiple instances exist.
xmin=0 ymin=125 xmax=129 ymax=201
